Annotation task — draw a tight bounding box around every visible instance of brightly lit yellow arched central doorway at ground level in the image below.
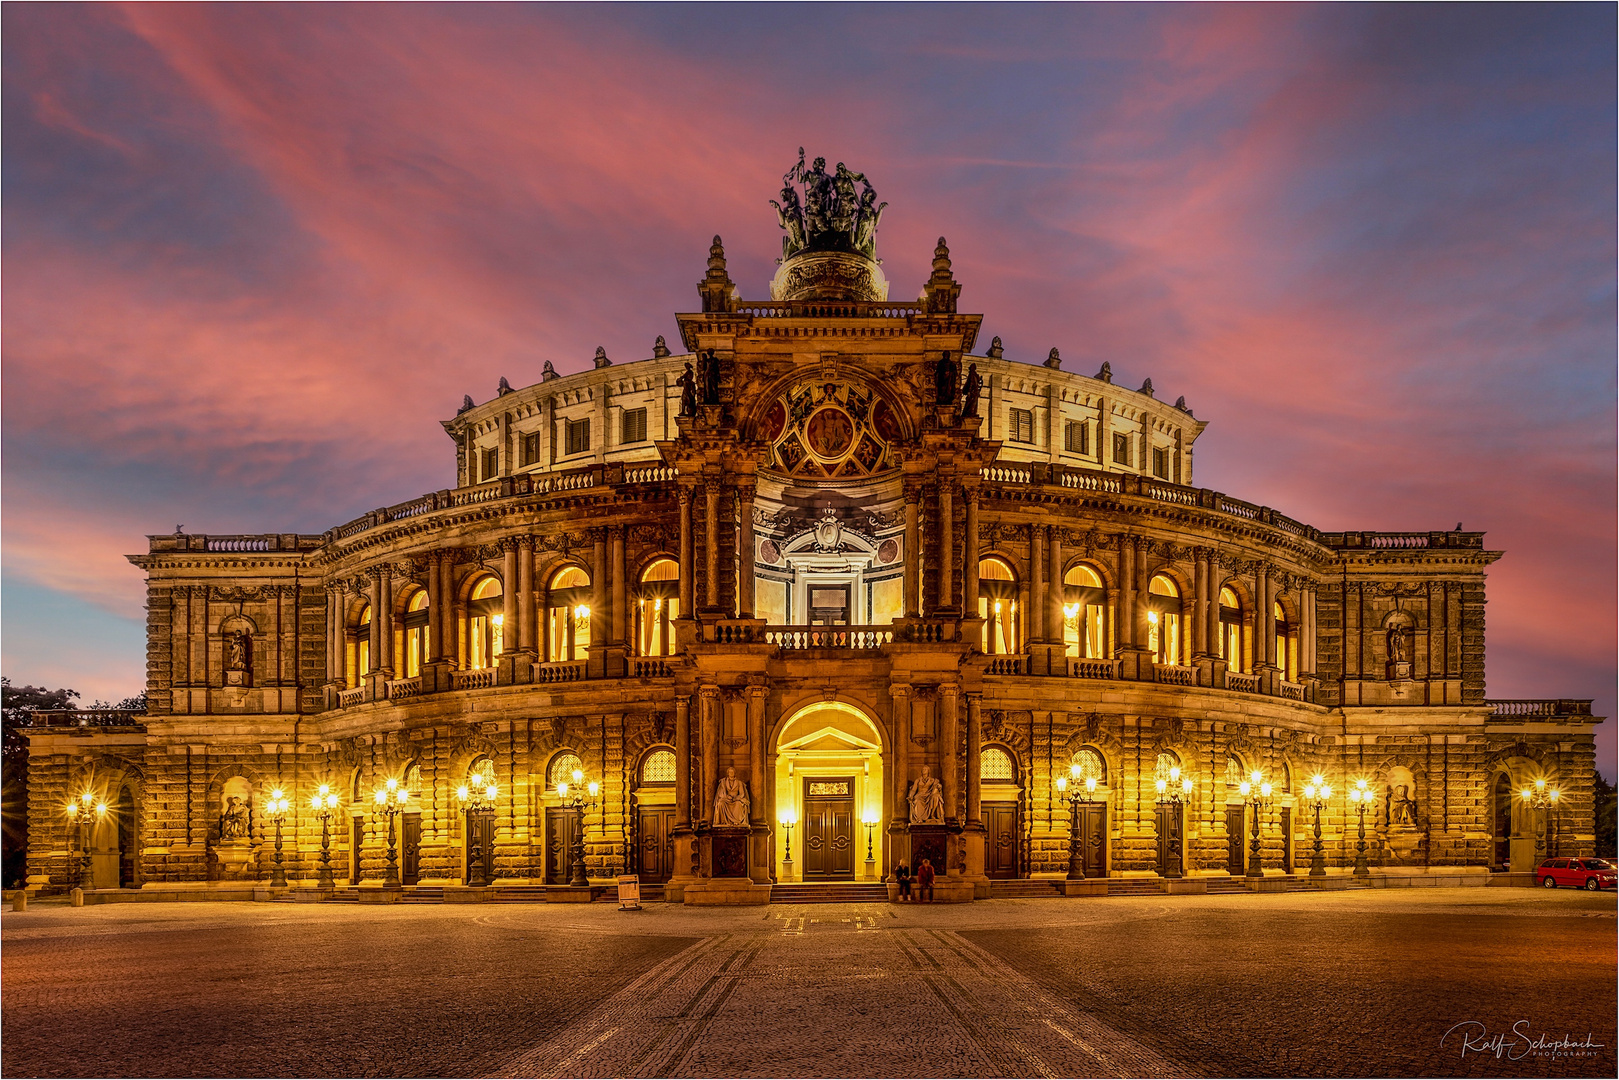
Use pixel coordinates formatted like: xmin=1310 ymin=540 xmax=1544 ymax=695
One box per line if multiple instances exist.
xmin=774 ymin=701 xmax=889 ymax=881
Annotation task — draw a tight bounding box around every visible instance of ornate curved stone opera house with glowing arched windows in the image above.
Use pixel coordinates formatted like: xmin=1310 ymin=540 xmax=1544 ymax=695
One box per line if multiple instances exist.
xmin=29 ymin=162 xmax=1598 ymax=902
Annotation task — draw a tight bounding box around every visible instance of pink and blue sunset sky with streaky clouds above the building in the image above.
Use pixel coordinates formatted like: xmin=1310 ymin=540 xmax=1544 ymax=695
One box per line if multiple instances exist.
xmin=0 ymin=3 xmax=1619 ymax=777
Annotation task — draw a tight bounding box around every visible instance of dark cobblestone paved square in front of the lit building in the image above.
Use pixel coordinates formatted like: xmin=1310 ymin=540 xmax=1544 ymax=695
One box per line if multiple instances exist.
xmin=0 ymin=889 xmax=1616 ymax=1077
